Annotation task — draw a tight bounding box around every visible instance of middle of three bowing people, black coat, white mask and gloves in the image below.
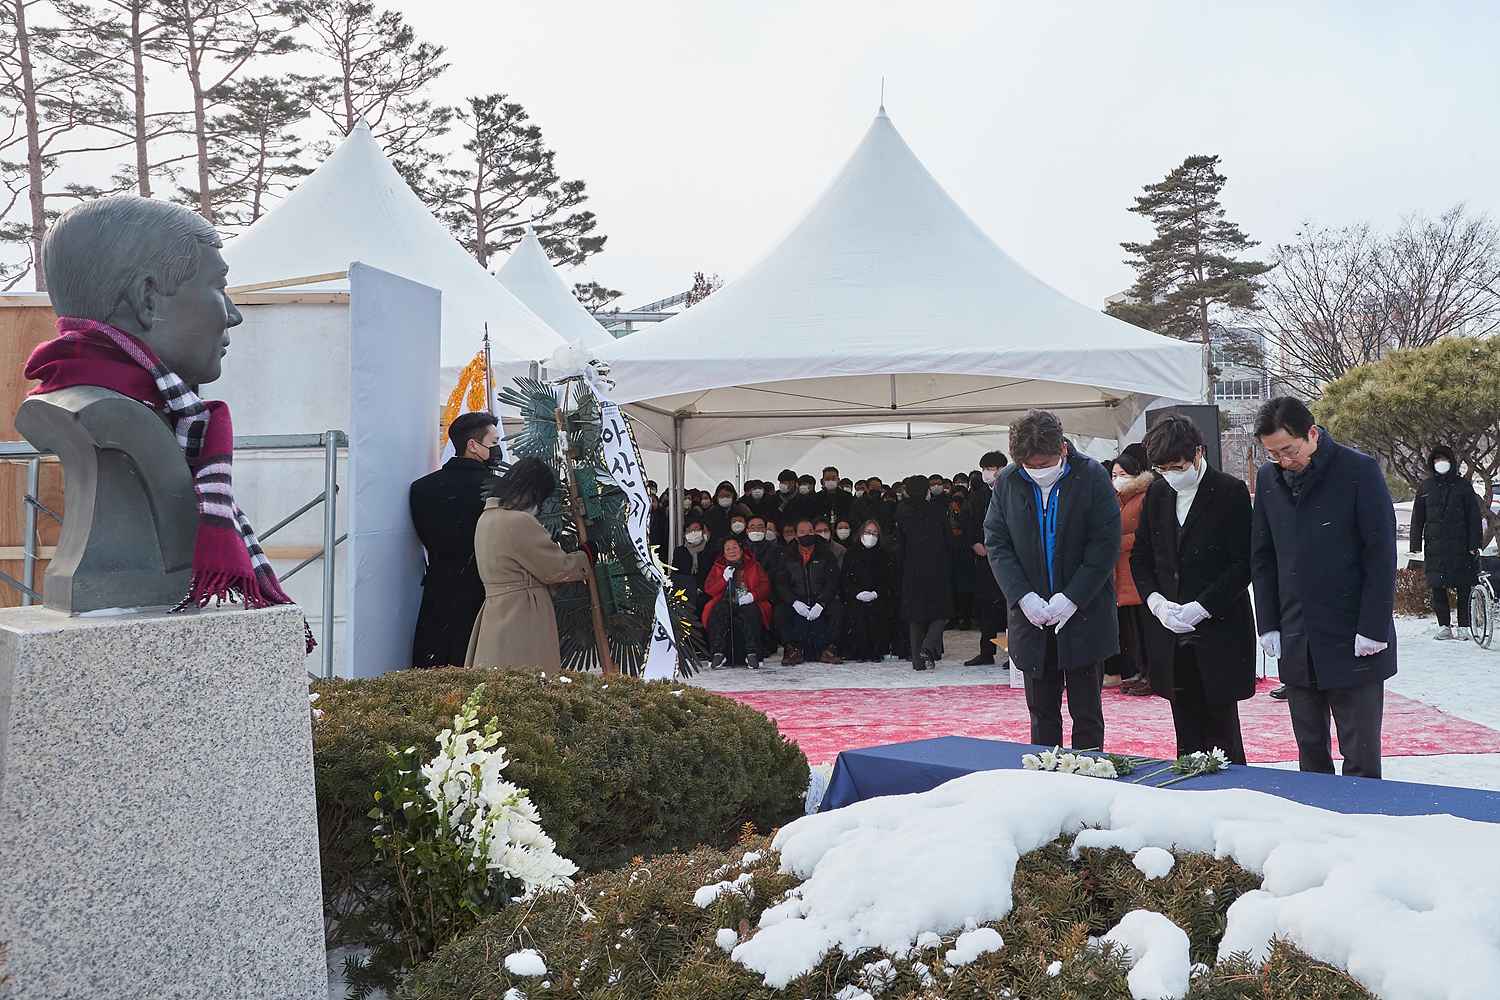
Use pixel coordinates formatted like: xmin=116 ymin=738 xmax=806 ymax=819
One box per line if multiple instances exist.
xmin=1130 ymin=417 xmax=1256 ymax=765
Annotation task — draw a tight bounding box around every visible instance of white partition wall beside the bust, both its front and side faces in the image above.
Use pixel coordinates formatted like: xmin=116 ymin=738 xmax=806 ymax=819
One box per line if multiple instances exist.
xmin=214 ymin=264 xmax=441 ymax=676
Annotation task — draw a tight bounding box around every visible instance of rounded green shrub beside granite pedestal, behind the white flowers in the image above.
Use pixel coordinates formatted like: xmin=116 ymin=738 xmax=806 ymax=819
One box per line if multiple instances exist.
xmin=312 ymin=669 xmax=807 ymax=948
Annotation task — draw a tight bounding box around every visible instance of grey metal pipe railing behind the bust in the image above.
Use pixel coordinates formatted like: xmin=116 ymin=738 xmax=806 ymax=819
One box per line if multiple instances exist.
xmin=0 ymin=430 xmax=350 ymax=678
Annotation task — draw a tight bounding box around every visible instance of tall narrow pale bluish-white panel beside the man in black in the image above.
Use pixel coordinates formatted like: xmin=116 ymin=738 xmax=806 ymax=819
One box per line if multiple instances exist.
xmin=347 ymin=264 xmax=443 ymax=678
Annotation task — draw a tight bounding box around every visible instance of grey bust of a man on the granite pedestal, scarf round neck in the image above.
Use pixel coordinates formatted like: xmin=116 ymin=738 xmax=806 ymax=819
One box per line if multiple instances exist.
xmin=15 ymin=195 xmax=243 ymax=613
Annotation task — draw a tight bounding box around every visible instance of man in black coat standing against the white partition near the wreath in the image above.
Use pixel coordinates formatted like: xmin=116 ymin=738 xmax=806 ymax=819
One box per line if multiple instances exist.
xmin=410 ymin=414 xmax=500 ymax=667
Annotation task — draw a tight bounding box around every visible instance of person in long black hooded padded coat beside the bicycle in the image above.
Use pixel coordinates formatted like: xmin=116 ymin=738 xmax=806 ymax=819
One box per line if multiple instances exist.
xmin=1412 ymin=444 xmax=1484 ymax=639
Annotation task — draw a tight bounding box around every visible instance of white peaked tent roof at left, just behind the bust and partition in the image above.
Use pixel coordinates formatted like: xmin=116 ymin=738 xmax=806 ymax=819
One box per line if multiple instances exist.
xmin=224 ymin=121 xmax=564 ymax=369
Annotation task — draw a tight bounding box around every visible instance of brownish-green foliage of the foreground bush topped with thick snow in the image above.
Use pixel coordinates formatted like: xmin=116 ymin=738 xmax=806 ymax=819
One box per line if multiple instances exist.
xmin=402 ymin=837 xmax=1370 ymax=1000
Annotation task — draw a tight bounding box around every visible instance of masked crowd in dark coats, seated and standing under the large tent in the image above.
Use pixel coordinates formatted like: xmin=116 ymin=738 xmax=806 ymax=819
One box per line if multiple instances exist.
xmin=648 ymin=461 xmax=1007 ymax=670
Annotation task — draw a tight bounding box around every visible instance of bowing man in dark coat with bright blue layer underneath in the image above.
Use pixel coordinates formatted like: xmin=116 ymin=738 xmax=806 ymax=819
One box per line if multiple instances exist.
xmin=984 ymin=409 xmax=1121 ymax=750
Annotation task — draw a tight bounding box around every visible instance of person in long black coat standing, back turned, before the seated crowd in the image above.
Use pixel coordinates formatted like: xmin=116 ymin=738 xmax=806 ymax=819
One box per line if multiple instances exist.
xmin=896 ymin=475 xmax=953 ymax=670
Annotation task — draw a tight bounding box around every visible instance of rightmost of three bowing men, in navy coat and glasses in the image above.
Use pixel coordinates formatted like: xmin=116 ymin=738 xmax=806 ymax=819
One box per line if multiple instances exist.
xmin=1251 ymin=396 xmax=1397 ymax=778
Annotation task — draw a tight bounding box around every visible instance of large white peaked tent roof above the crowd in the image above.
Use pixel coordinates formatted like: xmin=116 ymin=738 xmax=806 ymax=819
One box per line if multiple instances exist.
xmin=605 ymin=108 xmax=1203 ymax=451
